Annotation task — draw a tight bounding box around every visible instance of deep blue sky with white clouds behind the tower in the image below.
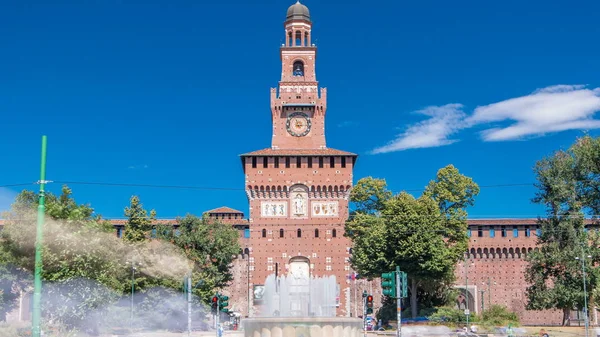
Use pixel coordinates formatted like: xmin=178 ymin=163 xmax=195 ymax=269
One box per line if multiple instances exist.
xmin=0 ymin=0 xmax=600 ymax=217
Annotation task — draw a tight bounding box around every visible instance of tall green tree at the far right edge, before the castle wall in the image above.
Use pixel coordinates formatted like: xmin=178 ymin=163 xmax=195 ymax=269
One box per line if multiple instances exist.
xmin=526 ymin=137 xmax=600 ymax=325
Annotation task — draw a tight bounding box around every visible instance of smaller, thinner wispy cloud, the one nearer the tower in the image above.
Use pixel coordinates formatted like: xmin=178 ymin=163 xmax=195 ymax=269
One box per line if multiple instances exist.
xmin=371 ymin=104 xmax=466 ymax=154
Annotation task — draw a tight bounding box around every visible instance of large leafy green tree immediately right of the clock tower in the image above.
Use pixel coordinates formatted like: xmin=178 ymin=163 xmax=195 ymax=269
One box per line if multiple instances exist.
xmin=346 ymin=165 xmax=479 ymax=317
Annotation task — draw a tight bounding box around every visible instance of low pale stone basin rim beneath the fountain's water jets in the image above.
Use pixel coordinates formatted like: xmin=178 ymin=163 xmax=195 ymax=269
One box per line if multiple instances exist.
xmin=242 ymin=317 xmax=363 ymax=337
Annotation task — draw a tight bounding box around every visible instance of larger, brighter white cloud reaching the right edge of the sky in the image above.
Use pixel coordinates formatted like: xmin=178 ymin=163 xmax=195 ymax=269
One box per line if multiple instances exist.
xmin=465 ymin=85 xmax=600 ymax=141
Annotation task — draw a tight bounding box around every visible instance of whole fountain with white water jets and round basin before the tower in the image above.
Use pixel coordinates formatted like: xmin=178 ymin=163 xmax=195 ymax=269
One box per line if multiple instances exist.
xmin=243 ymin=257 xmax=363 ymax=337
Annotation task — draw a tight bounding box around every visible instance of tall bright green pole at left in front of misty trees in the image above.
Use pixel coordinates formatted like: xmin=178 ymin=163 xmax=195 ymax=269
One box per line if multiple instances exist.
xmin=31 ymin=136 xmax=49 ymax=337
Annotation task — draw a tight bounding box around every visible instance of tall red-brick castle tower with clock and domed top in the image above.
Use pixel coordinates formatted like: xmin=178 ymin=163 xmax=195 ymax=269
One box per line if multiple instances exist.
xmin=241 ymin=2 xmax=357 ymax=316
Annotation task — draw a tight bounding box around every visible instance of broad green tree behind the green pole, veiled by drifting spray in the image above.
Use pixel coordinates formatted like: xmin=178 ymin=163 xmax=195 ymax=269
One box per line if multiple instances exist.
xmin=0 ymin=186 xmax=127 ymax=325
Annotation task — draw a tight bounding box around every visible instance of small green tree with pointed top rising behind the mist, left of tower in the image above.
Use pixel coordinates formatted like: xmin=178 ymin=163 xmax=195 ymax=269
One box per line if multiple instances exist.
xmin=123 ymin=195 xmax=156 ymax=242
